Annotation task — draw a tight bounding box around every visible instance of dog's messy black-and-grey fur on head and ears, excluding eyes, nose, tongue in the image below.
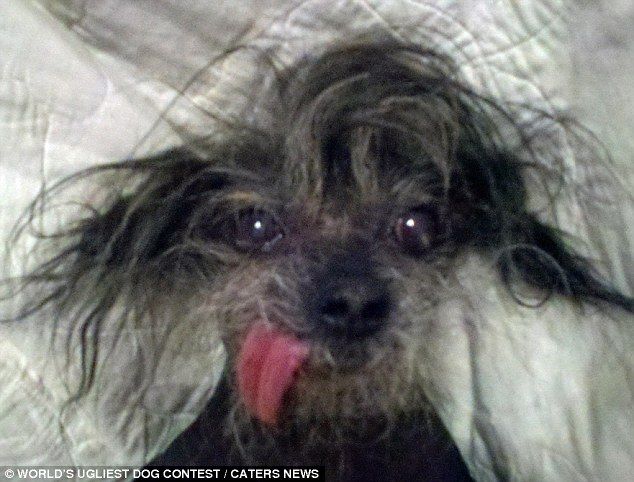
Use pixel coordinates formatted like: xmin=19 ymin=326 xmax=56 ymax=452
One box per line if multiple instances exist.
xmin=2 ymin=42 xmax=634 ymax=480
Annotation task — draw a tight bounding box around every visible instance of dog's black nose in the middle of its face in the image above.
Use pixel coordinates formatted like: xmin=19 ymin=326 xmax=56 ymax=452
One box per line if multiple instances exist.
xmin=317 ymin=277 xmax=391 ymax=339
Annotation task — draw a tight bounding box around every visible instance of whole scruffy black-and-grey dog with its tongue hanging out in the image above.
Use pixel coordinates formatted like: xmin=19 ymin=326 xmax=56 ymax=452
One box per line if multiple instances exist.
xmin=8 ymin=42 xmax=634 ymax=480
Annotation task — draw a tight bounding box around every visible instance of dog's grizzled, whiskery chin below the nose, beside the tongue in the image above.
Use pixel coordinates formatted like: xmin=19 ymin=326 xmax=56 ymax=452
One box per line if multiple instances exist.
xmin=230 ymin=324 xmax=422 ymax=443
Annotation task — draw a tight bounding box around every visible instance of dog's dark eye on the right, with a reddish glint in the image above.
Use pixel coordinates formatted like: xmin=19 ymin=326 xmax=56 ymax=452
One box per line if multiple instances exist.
xmin=393 ymin=206 xmax=439 ymax=255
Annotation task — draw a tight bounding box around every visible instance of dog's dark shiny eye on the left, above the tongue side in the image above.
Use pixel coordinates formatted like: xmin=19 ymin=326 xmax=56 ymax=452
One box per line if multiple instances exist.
xmin=233 ymin=209 xmax=284 ymax=251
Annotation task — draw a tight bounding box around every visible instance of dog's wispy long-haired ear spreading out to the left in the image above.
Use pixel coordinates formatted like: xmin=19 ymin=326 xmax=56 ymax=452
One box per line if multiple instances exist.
xmin=13 ymin=149 xmax=226 ymax=318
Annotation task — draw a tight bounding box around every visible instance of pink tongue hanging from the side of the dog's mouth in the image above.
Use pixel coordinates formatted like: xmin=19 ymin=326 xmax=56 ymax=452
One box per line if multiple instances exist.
xmin=237 ymin=324 xmax=309 ymax=425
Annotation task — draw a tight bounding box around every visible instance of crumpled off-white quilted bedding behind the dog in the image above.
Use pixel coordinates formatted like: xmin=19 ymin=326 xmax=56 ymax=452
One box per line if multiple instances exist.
xmin=0 ymin=0 xmax=634 ymax=480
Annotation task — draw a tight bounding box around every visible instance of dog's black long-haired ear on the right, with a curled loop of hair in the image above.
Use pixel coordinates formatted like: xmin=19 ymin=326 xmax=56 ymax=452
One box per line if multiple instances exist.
xmin=449 ymin=121 xmax=634 ymax=311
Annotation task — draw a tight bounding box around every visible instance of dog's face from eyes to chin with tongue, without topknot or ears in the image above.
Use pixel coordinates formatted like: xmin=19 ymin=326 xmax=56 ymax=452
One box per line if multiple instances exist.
xmin=205 ymin=146 xmax=455 ymax=427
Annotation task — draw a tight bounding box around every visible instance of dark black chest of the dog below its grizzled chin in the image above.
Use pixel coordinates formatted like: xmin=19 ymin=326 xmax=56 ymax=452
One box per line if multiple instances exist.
xmin=152 ymin=379 xmax=471 ymax=481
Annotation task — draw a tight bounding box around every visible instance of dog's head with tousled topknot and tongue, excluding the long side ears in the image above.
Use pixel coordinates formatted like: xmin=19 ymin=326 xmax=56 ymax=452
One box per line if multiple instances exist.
xmin=130 ymin=46 xmax=525 ymax=432
